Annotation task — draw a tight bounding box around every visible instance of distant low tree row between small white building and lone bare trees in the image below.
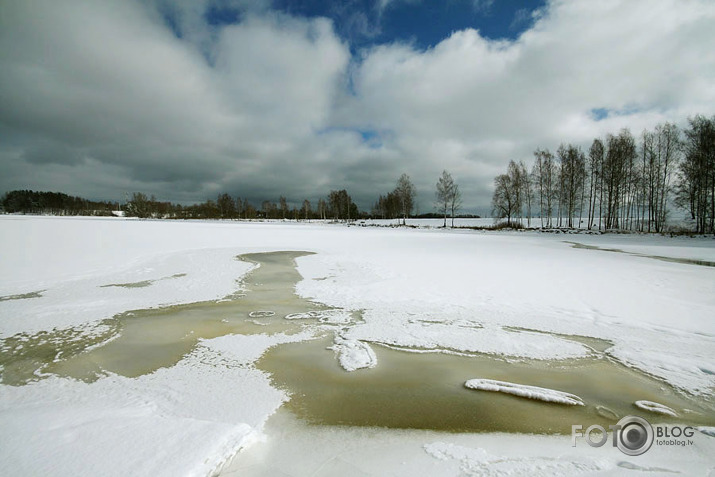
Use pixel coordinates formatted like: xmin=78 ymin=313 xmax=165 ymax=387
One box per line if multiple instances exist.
xmin=124 ymin=189 xmax=367 ymax=221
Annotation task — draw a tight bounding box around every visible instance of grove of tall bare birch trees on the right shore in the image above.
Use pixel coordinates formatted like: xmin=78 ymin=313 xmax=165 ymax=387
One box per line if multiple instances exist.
xmin=492 ymin=116 xmax=715 ymax=233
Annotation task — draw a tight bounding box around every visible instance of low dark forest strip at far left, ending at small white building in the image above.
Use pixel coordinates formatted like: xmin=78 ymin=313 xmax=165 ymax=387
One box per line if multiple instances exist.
xmin=0 ymin=190 xmax=120 ymax=216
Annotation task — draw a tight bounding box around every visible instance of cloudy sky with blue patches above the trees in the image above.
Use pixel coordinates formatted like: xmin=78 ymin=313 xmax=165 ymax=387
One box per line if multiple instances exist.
xmin=0 ymin=0 xmax=715 ymax=215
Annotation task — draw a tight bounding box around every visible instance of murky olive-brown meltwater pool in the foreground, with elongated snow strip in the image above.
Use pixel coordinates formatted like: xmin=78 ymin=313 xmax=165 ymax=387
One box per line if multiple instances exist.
xmin=256 ymin=337 xmax=715 ymax=434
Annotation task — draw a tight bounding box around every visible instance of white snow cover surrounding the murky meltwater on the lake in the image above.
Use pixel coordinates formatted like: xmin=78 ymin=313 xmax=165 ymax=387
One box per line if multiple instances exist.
xmin=0 ymin=216 xmax=715 ymax=475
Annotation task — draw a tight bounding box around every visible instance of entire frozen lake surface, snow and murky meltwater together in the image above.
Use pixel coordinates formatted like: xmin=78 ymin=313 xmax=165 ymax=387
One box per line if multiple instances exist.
xmin=0 ymin=216 xmax=715 ymax=475
